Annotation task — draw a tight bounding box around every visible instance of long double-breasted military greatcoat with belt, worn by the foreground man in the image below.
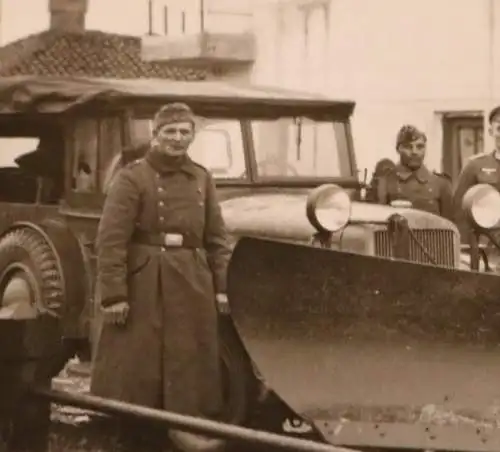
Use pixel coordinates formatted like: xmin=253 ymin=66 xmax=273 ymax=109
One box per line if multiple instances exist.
xmin=91 ymin=151 xmax=230 ymax=416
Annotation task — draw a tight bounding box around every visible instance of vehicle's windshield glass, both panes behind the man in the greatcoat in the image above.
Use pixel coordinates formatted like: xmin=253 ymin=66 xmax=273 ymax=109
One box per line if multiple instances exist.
xmin=133 ymin=117 xmax=354 ymax=180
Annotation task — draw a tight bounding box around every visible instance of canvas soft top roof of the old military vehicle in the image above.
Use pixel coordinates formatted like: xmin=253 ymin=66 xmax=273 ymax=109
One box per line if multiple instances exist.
xmin=0 ymin=76 xmax=354 ymax=116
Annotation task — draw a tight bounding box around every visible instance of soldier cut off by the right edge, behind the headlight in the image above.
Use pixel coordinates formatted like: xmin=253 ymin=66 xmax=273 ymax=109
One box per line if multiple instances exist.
xmin=453 ymin=106 xmax=500 ymax=233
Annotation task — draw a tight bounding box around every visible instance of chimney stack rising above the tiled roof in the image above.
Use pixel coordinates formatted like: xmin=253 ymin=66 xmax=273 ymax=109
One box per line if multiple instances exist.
xmin=49 ymin=0 xmax=88 ymax=33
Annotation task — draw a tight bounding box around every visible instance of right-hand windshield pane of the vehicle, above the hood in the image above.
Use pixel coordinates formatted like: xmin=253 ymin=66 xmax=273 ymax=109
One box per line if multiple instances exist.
xmin=252 ymin=117 xmax=353 ymax=178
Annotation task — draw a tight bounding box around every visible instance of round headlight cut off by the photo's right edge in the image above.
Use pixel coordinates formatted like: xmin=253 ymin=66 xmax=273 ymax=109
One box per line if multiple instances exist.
xmin=462 ymin=184 xmax=500 ymax=229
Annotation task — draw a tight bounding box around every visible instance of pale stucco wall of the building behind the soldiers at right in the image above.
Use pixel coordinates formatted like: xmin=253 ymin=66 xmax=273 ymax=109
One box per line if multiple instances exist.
xmin=253 ymin=0 xmax=500 ymax=175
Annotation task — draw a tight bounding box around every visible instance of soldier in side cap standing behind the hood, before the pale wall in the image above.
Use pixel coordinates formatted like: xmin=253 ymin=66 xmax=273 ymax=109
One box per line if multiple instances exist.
xmin=377 ymin=125 xmax=453 ymax=219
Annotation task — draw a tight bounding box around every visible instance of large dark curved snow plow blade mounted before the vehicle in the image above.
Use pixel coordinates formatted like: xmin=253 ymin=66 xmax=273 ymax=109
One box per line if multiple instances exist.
xmin=228 ymin=238 xmax=500 ymax=451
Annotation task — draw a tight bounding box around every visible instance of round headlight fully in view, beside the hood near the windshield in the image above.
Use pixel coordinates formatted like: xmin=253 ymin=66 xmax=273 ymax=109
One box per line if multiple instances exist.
xmin=306 ymin=184 xmax=351 ymax=232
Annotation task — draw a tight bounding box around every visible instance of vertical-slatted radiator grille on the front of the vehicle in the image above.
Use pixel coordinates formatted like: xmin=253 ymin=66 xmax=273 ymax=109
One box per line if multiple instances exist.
xmin=375 ymin=229 xmax=455 ymax=267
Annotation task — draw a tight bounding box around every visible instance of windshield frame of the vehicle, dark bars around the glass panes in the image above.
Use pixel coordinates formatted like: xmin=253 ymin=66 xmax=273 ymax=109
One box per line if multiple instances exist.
xmin=131 ymin=108 xmax=361 ymax=188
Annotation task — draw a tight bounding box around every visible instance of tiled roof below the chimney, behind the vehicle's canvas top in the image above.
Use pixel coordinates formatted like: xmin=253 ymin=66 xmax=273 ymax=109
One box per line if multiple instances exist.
xmin=0 ymin=30 xmax=207 ymax=80
